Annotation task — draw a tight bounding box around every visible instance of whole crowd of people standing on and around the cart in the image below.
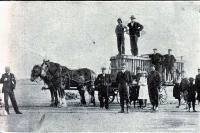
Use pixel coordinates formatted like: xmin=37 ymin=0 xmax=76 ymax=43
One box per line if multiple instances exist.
xmin=0 ymin=15 xmax=200 ymax=114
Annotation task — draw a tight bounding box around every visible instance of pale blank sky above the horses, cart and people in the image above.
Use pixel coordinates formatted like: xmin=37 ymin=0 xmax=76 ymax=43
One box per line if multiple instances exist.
xmin=0 ymin=1 xmax=200 ymax=79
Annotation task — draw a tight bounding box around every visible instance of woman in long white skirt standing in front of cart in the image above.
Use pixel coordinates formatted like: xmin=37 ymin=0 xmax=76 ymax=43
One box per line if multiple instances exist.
xmin=138 ymin=71 xmax=149 ymax=108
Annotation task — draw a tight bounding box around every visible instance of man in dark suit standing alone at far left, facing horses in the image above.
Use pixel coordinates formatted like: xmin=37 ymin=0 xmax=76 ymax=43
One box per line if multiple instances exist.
xmin=0 ymin=67 xmax=22 ymax=114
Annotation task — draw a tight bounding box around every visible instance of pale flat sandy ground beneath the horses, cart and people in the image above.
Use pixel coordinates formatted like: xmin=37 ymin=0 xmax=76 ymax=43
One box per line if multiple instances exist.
xmin=0 ymin=85 xmax=200 ymax=132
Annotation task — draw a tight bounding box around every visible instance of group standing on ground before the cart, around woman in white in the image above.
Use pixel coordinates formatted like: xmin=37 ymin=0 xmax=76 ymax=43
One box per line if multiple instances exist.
xmin=95 ymin=64 xmax=161 ymax=113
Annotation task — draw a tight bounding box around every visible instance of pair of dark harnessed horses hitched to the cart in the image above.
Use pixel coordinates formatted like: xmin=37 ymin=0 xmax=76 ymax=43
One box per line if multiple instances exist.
xmin=31 ymin=61 xmax=96 ymax=106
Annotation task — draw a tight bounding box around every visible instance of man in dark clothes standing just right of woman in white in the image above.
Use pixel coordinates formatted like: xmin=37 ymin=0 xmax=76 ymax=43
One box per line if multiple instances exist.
xmin=147 ymin=65 xmax=161 ymax=110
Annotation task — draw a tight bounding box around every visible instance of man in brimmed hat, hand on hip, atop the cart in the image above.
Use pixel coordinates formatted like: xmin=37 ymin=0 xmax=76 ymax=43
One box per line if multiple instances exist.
xmin=127 ymin=15 xmax=143 ymax=56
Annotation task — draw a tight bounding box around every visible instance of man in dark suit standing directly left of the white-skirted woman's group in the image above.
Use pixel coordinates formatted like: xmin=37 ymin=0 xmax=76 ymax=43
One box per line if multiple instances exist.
xmin=116 ymin=63 xmax=132 ymax=113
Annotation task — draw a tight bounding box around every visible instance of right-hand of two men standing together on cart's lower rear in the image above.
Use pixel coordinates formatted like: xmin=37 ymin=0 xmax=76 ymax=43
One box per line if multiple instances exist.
xmin=162 ymin=49 xmax=176 ymax=81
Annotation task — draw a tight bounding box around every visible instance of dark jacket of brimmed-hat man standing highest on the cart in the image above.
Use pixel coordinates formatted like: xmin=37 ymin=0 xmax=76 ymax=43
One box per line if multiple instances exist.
xmin=127 ymin=22 xmax=143 ymax=37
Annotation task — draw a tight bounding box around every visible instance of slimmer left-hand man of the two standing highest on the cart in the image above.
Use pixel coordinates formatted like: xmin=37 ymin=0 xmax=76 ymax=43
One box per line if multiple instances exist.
xmin=115 ymin=18 xmax=127 ymax=55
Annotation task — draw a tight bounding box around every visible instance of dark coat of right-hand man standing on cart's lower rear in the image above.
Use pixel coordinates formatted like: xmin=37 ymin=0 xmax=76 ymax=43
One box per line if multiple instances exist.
xmin=163 ymin=54 xmax=176 ymax=68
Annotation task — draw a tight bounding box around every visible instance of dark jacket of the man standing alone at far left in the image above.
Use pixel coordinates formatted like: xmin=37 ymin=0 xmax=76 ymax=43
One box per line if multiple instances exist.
xmin=0 ymin=73 xmax=16 ymax=93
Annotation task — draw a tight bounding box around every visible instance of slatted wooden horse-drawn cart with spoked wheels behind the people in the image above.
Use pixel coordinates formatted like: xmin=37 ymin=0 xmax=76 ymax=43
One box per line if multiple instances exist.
xmin=109 ymin=55 xmax=184 ymax=103
